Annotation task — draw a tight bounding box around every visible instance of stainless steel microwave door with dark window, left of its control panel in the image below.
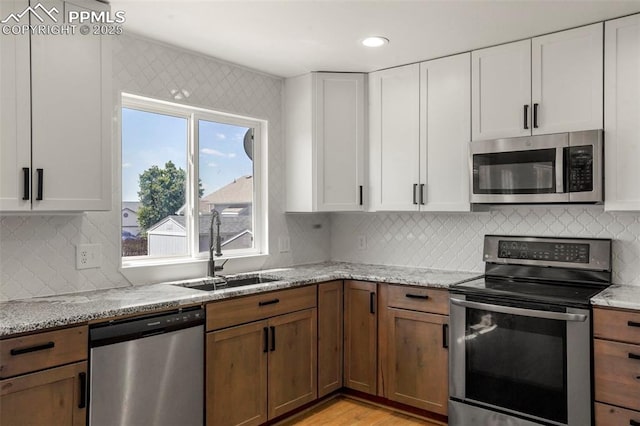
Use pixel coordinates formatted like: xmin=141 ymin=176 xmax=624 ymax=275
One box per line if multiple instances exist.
xmin=470 ymin=133 xmax=569 ymax=203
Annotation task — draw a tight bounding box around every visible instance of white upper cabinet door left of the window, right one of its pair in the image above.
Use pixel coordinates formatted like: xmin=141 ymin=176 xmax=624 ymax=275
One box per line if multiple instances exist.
xmin=31 ymin=0 xmax=112 ymax=210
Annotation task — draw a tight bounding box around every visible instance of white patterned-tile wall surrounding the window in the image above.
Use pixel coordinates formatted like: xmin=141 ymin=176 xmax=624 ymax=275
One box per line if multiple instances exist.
xmin=0 ymin=35 xmax=330 ymax=300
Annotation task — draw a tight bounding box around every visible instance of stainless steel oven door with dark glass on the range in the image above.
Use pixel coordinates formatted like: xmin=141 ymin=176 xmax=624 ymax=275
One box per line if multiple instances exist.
xmin=449 ymin=294 xmax=591 ymax=426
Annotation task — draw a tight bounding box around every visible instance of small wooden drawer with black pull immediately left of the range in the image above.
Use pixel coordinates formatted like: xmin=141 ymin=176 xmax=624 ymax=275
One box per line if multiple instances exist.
xmin=387 ymin=285 xmax=449 ymax=315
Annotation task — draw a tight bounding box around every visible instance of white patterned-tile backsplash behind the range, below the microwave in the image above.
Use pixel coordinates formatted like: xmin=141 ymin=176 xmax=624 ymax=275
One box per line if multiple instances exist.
xmin=331 ymin=206 xmax=640 ymax=285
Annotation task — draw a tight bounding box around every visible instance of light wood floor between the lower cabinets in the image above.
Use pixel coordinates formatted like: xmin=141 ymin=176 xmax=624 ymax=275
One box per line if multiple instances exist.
xmin=278 ymin=396 xmax=440 ymax=426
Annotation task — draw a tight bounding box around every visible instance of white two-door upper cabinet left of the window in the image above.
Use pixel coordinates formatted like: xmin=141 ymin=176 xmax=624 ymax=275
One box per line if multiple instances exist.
xmin=0 ymin=0 xmax=112 ymax=211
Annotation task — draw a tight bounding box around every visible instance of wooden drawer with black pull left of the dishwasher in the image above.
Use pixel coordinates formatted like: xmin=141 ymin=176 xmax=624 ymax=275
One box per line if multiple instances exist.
xmin=0 ymin=326 xmax=87 ymax=378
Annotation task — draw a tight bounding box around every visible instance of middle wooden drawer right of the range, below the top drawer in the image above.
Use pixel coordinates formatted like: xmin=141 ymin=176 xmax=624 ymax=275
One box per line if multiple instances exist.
xmin=593 ymin=339 xmax=640 ymax=410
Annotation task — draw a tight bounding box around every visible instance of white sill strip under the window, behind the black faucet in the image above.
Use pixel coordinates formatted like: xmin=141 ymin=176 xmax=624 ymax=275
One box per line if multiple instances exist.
xmin=120 ymin=252 xmax=269 ymax=285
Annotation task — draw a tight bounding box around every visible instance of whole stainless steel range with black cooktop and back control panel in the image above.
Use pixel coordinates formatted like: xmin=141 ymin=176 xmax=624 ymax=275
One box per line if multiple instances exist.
xmin=449 ymin=235 xmax=611 ymax=426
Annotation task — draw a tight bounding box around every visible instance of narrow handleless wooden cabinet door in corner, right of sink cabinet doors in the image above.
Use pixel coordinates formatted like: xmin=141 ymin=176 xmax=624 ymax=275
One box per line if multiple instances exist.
xmin=318 ymin=281 xmax=343 ymax=398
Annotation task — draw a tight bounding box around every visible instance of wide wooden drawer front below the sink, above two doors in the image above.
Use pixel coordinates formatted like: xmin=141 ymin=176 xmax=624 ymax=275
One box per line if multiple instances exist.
xmin=207 ymin=285 xmax=316 ymax=331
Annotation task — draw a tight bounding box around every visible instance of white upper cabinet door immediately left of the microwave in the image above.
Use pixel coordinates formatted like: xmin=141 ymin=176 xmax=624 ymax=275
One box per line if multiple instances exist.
xmin=420 ymin=53 xmax=471 ymax=211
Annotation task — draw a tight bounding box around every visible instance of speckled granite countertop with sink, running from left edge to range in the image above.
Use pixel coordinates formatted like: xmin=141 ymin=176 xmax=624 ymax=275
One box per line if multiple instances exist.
xmin=0 ymin=262 xmax=481 ymax=336
